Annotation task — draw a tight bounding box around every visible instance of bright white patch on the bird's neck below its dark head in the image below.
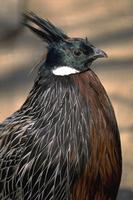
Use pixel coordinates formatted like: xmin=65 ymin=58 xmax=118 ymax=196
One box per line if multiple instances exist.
xmin=52 ymin=66 xmax=80 ymax=76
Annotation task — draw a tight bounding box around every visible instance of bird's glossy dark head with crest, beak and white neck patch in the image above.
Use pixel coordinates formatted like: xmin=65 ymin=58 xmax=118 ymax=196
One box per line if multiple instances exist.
xmin=25 ymin=13 xmax=107 ymax=76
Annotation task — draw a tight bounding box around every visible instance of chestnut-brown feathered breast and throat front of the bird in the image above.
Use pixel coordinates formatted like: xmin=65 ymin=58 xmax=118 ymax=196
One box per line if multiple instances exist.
xmin=71 ymin=70 xmax=122 ymax=200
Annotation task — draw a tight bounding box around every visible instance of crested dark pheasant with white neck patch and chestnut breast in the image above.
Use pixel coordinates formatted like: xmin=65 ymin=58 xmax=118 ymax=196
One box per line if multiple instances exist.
xmin=0 ymin=11 xmax=122 ymax=200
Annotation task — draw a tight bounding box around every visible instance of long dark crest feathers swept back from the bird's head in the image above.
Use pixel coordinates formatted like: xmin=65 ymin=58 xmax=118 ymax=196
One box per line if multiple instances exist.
xmin=24 ymin=12 xmax=69 ymax=43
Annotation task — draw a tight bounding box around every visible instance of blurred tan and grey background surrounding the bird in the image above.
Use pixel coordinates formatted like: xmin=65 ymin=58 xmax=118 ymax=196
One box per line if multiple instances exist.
xmin=0 ymin=0 xmax=133 ymax=200
